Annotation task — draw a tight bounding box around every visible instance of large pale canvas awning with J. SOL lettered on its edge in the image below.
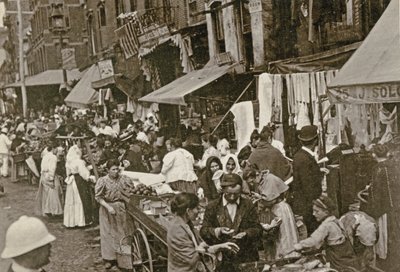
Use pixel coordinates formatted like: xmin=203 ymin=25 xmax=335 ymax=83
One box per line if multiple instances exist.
xmin=328 ymin=0 xmax=400 ymax=104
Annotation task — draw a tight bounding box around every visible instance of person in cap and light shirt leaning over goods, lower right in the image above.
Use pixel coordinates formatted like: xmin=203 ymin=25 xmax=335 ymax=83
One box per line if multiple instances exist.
xmin=294 ymin=196 xmax=359 ymax=272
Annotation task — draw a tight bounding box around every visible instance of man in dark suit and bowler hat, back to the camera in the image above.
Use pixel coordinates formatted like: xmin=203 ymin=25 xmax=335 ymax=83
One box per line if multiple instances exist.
xmin=289 ymin=126 xmax=324 ymax=233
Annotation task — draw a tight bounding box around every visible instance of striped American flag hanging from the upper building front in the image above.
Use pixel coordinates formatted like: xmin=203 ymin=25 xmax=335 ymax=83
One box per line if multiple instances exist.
xmin=115 ymin=21 xmax=139 ymax=59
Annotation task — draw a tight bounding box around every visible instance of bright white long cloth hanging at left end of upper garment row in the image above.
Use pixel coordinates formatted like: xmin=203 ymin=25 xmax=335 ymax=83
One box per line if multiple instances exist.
xmin=258 ymin=73 xmax=273 ymax=130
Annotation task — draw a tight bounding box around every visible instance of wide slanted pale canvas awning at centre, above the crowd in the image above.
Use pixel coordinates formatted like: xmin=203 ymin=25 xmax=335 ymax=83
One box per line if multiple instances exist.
xmin=139 ymin=63 xmax=239 ymax=105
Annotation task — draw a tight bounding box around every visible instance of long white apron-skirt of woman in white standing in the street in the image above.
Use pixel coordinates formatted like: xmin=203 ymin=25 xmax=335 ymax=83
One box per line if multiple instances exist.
xmin=64 ymin=176 xmax=86 ymax=228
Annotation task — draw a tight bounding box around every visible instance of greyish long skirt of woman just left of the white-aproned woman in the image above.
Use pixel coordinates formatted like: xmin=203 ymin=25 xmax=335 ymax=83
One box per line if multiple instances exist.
xmin=39 ymin=176 xmax=63 ymax=215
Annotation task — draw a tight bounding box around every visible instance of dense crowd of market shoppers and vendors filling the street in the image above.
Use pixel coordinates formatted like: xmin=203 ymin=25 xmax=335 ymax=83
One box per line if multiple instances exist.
xmin=0 ymin=103 xmax=400 ymax=271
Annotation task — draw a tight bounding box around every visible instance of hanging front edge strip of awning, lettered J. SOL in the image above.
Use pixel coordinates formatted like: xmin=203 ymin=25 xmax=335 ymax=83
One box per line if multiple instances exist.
xmin=328 ymin=83 xmax=400 ymax=104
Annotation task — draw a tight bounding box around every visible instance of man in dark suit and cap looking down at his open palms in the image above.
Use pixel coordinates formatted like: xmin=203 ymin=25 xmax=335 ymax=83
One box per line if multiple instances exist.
xmin=200 ymin=174 xmax=261 ymax=272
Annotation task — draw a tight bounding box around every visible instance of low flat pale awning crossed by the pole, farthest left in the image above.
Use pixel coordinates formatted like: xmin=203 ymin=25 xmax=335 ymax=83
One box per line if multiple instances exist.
xmin=5 ymin=69 xmax=82 ymax=88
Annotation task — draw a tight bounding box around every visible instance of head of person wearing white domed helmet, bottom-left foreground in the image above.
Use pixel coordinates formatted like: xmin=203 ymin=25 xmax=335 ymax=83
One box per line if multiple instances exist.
xmin=1 ymin=215 xmax=56 ymax=272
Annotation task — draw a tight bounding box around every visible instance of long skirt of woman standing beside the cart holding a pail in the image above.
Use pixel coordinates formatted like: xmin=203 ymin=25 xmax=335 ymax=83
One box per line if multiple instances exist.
xmin=99 ymin=202 xmax=127 ymax=261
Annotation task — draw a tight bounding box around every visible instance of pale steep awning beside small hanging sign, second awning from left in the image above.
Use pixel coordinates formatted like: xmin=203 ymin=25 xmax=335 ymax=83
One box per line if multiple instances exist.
xmin=64 ymin=64 xmax=100 ymax=108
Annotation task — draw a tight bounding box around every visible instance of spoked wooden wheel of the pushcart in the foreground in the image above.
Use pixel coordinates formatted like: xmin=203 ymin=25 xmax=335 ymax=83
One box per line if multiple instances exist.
xmin=132 ymin=228 xmax=153 ymax=272
